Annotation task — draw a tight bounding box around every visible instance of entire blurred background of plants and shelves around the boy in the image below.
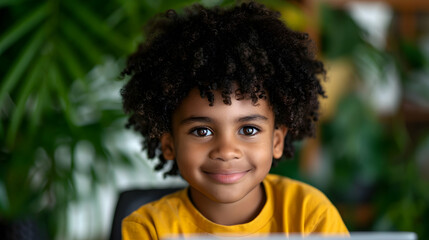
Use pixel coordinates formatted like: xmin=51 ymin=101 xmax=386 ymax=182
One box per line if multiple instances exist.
xmin=0 ymin=0 xmax=429 ymax=239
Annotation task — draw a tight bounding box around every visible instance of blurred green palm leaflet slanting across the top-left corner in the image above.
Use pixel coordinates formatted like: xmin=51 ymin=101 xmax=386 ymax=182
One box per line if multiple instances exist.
xmin=0 ymin=2 xmax=48 ymax=55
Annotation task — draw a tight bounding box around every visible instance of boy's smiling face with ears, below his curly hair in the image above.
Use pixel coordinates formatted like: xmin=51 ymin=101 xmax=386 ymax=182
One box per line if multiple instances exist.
xmin=161 ymin=89 xmax=287 ymax=206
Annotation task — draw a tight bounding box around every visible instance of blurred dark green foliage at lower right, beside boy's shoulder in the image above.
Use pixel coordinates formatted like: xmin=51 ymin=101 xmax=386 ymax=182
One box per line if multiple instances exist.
xmin=315 ymin=95 xmax=429 ymax=239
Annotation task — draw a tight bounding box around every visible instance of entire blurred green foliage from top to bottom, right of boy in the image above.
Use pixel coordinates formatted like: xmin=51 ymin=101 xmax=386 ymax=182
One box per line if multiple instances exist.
xmin=301 ymin=2 xmax=429 ymax=239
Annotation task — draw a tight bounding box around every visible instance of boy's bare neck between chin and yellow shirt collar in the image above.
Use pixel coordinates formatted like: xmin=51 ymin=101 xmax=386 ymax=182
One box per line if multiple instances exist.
xmin=188 ymin=183 xmax=266 ymax=226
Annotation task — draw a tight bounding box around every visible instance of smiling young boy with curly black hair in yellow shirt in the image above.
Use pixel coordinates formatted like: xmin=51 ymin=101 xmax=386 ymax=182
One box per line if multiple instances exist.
xmin=122 ymin=2 xmax=348 ymax=239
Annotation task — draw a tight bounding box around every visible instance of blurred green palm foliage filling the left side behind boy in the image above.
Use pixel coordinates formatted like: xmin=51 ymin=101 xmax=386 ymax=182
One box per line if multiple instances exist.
xmin=0 ymin=0 xmax=237 ymax=236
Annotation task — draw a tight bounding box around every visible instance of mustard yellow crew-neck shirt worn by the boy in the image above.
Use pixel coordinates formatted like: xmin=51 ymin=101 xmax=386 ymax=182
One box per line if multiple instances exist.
xmin=122 ymin=174 xmax=348 ymax=240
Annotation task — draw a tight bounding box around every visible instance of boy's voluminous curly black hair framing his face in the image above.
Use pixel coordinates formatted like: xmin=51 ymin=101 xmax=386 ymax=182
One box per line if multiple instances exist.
xmin=121 ymin=2 xmax=326 ymax=175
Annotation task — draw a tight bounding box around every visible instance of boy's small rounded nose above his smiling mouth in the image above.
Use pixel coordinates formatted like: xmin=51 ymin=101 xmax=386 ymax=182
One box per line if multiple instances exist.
xmin=209 ymin=136 xmax=242 ymax=161
